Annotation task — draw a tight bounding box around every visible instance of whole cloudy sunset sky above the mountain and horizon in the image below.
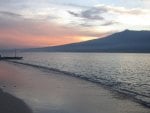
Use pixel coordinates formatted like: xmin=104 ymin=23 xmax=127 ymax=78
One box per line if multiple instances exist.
xmin=0 ymin=0 xmax=150 ymax=49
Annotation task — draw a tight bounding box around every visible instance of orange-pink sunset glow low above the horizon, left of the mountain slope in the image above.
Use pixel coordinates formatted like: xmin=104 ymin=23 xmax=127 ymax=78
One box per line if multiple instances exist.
xmin=0 ymin=30 xmax=96 ymax=48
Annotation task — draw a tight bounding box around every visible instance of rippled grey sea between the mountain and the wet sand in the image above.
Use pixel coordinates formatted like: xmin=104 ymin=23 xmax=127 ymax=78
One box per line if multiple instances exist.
xmin=19 ymin=52 xmax=150 ymax=104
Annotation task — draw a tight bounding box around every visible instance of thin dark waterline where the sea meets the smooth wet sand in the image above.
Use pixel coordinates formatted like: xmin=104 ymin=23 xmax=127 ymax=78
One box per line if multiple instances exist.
xmin=8 ymin=61 xmax=150 ymax=108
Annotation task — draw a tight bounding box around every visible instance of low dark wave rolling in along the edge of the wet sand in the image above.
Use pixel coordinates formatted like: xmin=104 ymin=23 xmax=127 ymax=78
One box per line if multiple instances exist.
xmin=10 ymin=61 xmax=150 ymax=108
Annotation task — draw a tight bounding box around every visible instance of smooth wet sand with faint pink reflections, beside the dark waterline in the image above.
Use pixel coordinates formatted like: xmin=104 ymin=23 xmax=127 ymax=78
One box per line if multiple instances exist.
xmin=0 ymin=62 xmax=150 ymax=113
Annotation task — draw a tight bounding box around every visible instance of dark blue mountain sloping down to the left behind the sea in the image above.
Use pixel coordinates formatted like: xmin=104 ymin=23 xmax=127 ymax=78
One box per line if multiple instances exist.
xmin=26 ymin=30 xmax=150 ymax=52
